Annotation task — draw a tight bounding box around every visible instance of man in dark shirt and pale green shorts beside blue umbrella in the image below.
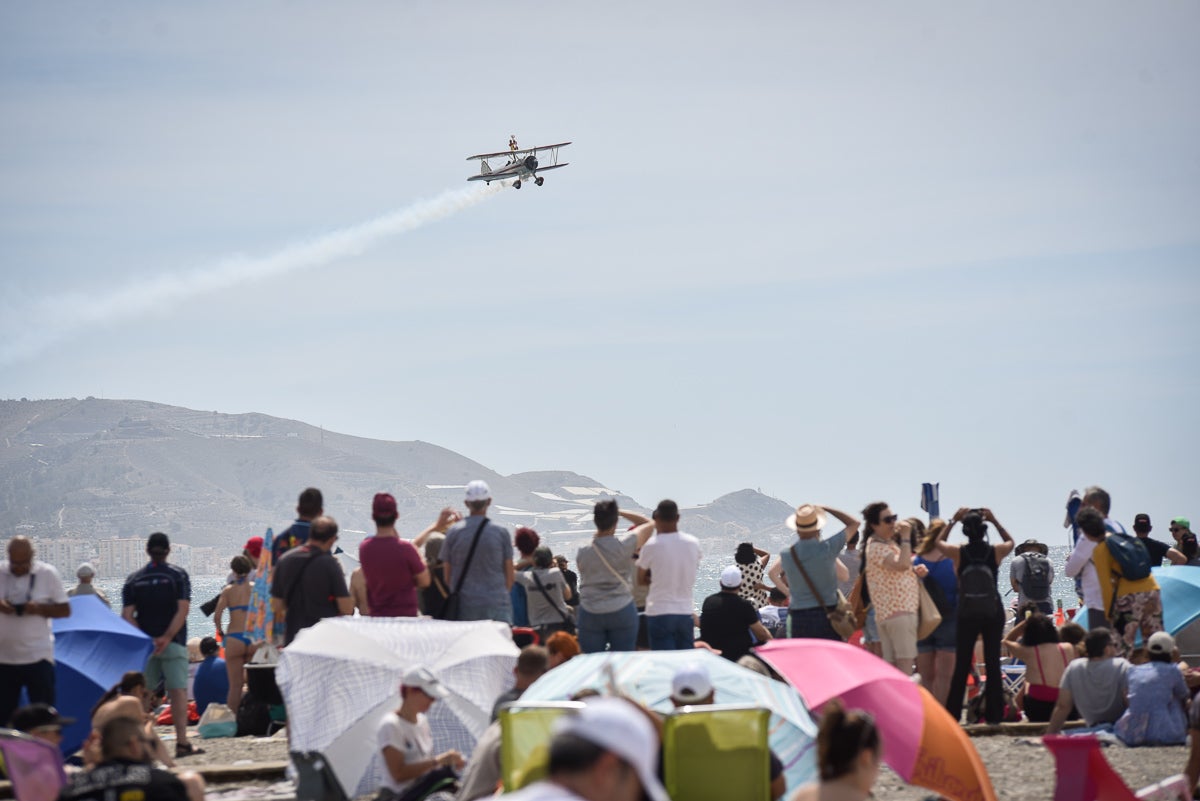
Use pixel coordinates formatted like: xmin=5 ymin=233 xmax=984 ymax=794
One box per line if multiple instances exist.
xmin=121 ymin=531 xmax=204 ymax=757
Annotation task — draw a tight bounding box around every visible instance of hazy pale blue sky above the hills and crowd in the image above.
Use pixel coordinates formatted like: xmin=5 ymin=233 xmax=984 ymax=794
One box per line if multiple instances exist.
xmin=0 ymin=0 xmax=1200 ymax=542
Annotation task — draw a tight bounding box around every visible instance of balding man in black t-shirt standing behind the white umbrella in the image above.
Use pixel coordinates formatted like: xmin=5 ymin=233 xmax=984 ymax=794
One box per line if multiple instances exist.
xmin=271 ymin=516 xmax=354 ymax=645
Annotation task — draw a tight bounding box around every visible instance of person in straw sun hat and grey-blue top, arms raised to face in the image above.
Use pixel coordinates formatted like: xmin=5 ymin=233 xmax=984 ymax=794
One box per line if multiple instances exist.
xmin=770 ymin=504 xmax=859 ymax=640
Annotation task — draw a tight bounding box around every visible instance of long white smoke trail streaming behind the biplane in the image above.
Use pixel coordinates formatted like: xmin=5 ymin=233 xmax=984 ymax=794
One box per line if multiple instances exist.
xmin=0 ymin=181 xmax=508 ymax=366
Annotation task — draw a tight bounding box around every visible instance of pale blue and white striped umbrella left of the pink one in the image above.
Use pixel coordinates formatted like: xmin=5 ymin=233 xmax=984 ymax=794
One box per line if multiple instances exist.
xmin=521 ymin=650 xmax=817 ymax=793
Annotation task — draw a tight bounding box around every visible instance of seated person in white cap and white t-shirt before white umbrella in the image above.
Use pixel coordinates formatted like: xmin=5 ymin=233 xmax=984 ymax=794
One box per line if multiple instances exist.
xmin=376 ymin=666 xmax=464 ymax=799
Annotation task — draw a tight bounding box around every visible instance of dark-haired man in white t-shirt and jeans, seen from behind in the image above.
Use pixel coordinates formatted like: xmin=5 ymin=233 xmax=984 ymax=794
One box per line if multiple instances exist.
xmin=637 ymin=500 xmax=702 ymax=651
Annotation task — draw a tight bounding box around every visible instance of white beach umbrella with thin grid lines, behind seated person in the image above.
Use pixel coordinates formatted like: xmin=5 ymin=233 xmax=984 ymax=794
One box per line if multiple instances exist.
xmin=276 ymin=618 xmax=518 ymax=796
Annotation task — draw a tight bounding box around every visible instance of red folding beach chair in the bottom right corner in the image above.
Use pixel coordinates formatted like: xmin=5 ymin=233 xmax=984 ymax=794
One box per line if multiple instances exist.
xmin=1042 ymin=734 xmax=1192 ymax=801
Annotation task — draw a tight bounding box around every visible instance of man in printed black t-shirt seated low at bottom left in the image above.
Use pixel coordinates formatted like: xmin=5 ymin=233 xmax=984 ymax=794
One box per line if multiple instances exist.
xmin=59 ymin=717 xmax=204 ymax=801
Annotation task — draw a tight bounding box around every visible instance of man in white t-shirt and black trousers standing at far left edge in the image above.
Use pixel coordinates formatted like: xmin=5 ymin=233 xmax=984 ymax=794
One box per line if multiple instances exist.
xmin=0 ymin=537 xmax=71 ymax=725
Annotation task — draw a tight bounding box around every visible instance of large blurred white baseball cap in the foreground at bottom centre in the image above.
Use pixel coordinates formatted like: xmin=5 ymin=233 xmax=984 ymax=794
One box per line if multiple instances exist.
xmin=554 ymin=698 xmax=671 ymax=801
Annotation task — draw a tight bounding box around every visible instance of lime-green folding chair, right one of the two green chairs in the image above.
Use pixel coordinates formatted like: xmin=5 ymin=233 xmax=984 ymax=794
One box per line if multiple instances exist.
xmin=662 ymin=705 xmax=770 ymax=801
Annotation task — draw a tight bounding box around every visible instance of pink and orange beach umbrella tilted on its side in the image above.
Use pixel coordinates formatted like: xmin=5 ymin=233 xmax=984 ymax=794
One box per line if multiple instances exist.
xmin=755 ymin=639 xmax=996 ymax=801
